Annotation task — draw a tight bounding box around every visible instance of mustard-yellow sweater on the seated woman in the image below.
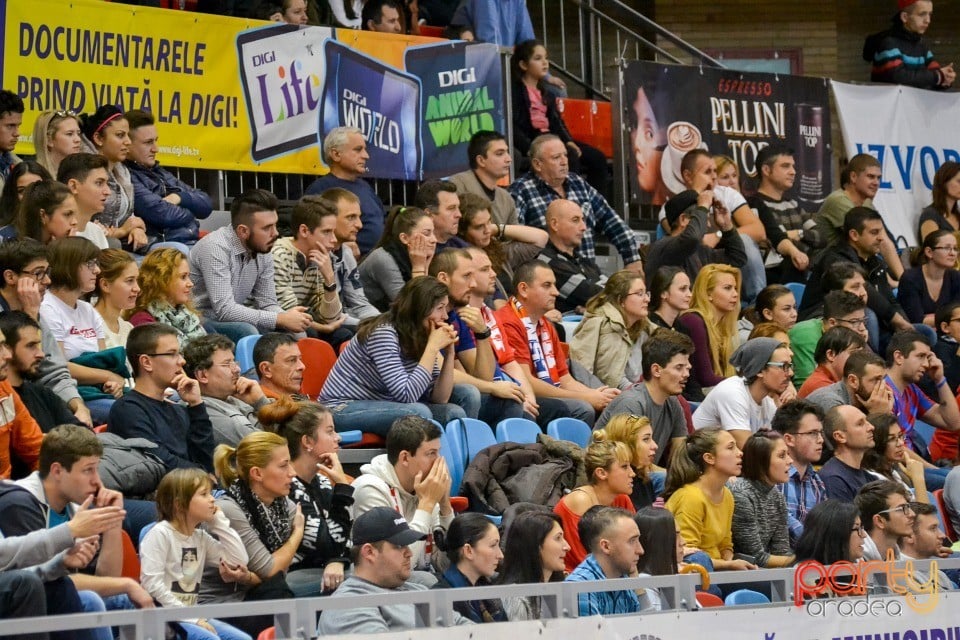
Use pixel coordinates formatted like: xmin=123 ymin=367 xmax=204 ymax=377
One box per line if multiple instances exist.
xmin=667 ymin=484 xmax=733 ymax=559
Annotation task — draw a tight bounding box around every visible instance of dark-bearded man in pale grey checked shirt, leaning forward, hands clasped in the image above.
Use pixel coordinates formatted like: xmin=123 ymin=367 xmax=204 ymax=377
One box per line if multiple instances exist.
xmin=190 ymin=189 xmax=313 ymax=341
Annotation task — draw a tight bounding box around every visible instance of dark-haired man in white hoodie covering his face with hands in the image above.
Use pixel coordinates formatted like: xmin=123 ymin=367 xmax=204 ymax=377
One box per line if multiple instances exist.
xmin=353 ymin=415 xmax=454 ymax=583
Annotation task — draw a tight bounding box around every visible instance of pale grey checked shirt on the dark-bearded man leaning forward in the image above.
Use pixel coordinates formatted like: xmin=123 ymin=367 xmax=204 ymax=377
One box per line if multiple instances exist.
xmin=190 ymin=225 xmax=283 ymax=332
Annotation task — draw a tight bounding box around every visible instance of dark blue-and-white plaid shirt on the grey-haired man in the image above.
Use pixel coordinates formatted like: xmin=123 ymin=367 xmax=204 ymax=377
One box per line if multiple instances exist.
xmin=509 ymin=172 xmax=640 ymax=264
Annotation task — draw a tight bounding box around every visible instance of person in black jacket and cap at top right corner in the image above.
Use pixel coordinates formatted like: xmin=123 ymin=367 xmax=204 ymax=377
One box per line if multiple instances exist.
xmin=863 ymin=0 xmax=957 ymax=91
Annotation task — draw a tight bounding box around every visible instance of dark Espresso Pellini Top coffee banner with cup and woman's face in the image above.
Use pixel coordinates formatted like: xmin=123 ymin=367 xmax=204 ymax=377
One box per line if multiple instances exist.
xmin=622 ymin=61 xmax=832 ymax=211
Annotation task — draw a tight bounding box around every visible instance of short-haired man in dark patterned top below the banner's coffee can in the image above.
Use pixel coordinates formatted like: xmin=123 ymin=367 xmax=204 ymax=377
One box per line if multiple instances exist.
xmin=747 ymin=145 xmax=825 ymax=283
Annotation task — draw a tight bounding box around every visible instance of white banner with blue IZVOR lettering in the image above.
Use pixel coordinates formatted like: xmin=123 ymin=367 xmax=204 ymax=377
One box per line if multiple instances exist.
xmin=831 ymin=82 xmax=960 ymax=246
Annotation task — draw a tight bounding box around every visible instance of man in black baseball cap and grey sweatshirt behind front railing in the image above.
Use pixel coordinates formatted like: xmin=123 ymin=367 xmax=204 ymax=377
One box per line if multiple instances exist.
xmin=317 ymin=507 xmax=473 ymax=636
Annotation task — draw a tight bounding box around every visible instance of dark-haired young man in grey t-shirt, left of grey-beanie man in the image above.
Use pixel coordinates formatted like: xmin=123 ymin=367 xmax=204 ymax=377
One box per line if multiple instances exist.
xmin=596 ymin=329 xmax=693 ymax=467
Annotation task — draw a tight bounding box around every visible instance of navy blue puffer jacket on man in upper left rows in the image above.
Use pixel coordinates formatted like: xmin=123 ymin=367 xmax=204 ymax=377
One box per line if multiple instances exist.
xmin=124 ymin=160 xmax=213 ymax=244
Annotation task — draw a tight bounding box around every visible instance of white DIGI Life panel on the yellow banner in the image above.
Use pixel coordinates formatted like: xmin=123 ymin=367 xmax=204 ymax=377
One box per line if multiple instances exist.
xmin=237 ymin=24 xmax=333 ymax=162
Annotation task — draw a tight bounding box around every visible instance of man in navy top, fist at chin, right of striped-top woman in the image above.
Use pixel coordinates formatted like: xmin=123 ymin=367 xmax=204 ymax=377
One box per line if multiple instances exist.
xmin=430 ymin=249 xmax=524 ymax=424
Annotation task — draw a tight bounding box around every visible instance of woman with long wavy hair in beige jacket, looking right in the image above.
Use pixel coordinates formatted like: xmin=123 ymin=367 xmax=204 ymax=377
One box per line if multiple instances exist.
xmin=570 ymin=270 xmax=655 ymax=389
